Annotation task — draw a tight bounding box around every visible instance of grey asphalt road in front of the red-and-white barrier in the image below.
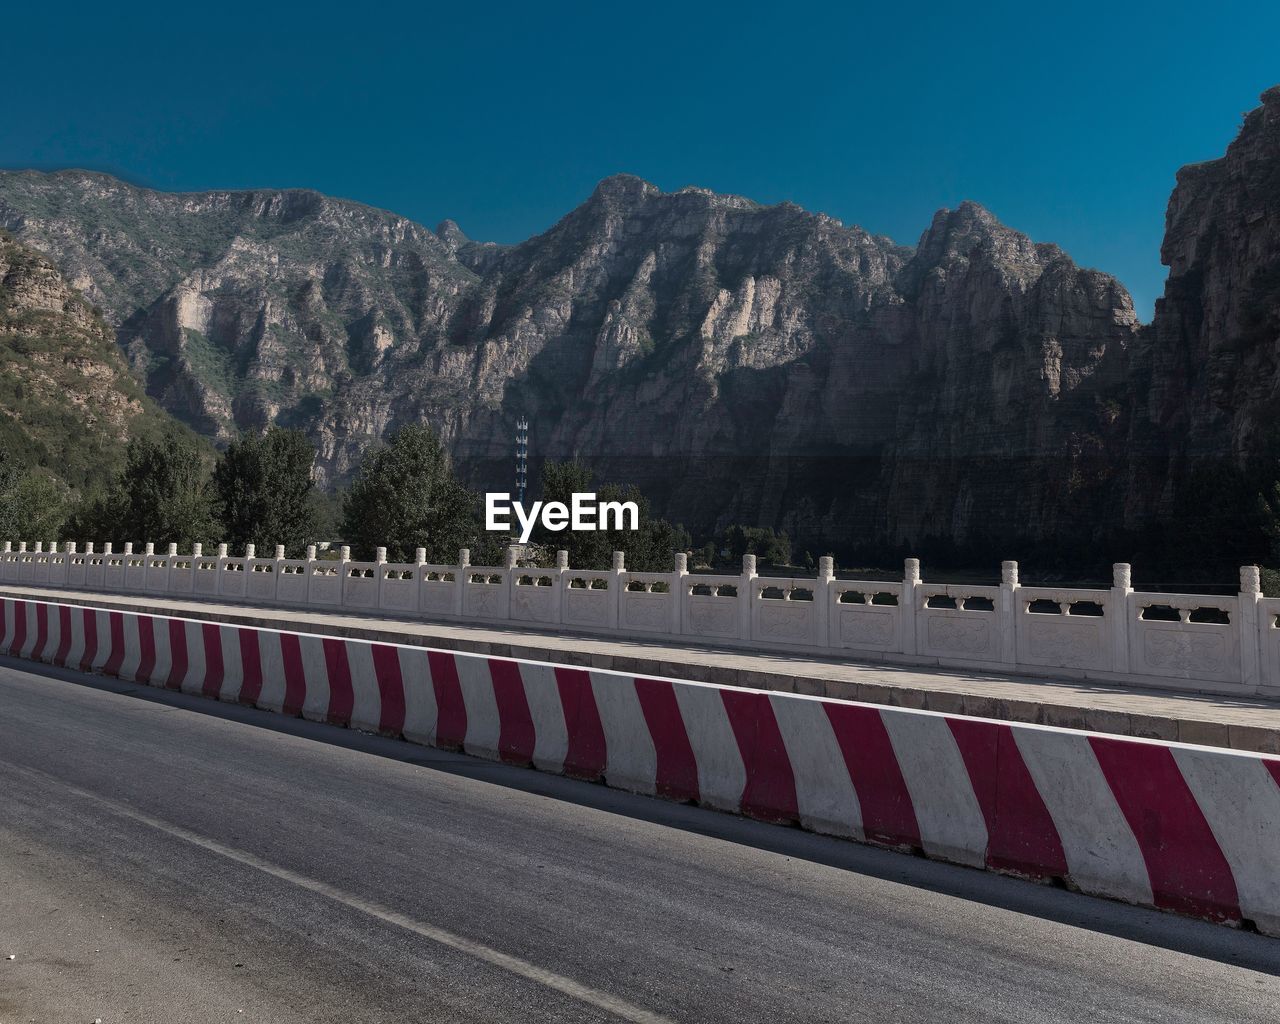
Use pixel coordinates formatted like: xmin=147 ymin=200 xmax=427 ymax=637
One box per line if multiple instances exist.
xmin=0 ymin=659 xmax=1280 ymax=1024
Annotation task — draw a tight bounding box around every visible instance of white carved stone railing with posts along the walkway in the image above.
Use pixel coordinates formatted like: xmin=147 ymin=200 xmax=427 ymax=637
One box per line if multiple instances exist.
xmin=0 ymin=541 xmax=1280 ymax=696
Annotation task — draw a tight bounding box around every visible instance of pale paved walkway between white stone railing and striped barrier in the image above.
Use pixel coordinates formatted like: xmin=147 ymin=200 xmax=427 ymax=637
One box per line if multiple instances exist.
xmin=0 ymin=585 xmax=1280 ymax=754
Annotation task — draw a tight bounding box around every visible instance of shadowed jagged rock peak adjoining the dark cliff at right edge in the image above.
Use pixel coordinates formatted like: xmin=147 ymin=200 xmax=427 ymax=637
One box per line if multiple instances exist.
xmin=882 ymin=204 xmax=1139 ymax=547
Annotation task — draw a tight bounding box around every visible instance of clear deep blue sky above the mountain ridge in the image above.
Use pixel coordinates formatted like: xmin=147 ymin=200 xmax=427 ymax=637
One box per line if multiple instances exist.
xmin=0 ymin=0 xmax=1280 ymax=319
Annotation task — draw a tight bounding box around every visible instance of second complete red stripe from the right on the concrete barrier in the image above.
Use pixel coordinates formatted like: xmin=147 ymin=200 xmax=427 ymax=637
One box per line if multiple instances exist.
xmin=947 ymin=718 xmax=1066 ymax=878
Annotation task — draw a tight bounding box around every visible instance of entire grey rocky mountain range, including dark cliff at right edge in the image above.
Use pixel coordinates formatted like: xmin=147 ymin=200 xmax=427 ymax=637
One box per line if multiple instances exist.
xmin=0 ymin=90 xmax=1280 ymax=563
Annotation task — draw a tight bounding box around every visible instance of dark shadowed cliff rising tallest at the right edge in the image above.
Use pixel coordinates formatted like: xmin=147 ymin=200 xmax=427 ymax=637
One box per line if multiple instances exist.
xmin=1116 ymin=87 xmax=1280 ymax=561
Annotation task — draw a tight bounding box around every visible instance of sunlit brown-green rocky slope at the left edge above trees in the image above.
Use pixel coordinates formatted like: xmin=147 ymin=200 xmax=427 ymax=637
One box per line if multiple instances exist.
xmin=0 ymin=233 xmax=183 ymax=488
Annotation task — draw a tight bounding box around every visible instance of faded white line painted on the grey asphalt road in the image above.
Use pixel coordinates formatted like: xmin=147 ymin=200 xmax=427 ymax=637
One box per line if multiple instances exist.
xmin=5 ymin=762 xmax=675 ymax=1024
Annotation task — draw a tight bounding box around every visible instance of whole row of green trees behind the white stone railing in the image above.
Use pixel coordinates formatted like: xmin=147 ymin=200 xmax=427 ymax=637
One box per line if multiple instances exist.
xmin=0 ymin=425 xmax=773 ymax=572
